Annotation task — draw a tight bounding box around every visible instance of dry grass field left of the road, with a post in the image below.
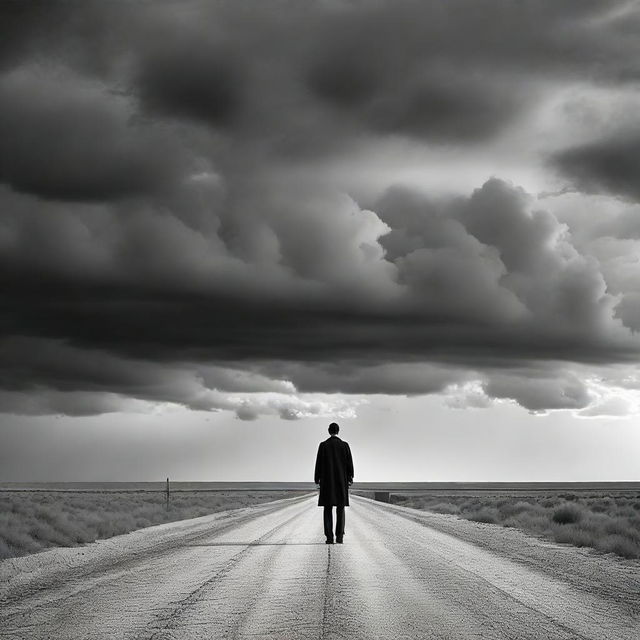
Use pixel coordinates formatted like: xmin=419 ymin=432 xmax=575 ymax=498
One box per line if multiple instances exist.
xmin=0 ymin=491 xmax=304 ymax=559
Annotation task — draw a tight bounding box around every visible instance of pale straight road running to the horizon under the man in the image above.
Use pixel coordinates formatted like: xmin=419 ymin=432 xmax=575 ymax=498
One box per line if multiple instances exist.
xmin=0 ymin=496 xmax=640 ymax=640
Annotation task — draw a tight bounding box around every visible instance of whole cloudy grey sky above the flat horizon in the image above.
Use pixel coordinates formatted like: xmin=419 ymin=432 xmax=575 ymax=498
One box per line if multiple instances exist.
xmin=0 ymin=0 xmax=640 ymax=481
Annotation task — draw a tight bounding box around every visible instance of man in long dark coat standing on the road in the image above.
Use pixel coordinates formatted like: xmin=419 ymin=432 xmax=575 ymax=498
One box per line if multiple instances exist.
xmin=314 ymin=422 xmax=353 ymax=544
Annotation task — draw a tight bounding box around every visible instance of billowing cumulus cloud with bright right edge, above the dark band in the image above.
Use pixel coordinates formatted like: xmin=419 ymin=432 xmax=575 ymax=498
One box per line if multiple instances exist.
xmin=379 ymin=179 xmax=616 ymax=342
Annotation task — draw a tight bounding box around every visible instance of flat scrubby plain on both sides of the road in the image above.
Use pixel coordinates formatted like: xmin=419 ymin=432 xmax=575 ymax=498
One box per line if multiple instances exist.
xmin=0 ymin=482 xmax=640 ymax=559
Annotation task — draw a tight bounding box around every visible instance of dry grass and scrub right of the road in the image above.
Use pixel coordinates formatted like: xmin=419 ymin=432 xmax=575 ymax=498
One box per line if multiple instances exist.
xmin=391 ymin=493 xmax=640 ymax=558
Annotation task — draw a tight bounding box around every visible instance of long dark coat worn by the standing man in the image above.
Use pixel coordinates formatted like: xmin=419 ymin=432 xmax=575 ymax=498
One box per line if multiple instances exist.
xmin=314 ymin=436 xmax=353 ymax=507
